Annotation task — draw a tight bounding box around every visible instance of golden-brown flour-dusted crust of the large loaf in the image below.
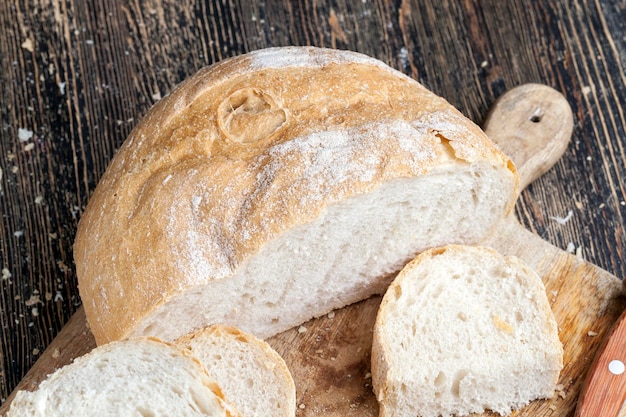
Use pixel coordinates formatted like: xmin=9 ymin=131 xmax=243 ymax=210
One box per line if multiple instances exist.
xmin=74 ymin=47 xmax=517 ymax=344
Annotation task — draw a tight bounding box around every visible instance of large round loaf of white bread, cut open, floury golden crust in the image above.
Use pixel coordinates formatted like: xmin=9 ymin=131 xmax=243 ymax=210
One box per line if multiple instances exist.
xmin=74 ymin=47 xmax=518 ymax=344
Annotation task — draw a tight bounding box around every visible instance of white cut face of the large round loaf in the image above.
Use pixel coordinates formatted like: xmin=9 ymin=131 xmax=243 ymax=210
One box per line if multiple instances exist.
xmin=132 ymin=159 xmax=510 ymax=340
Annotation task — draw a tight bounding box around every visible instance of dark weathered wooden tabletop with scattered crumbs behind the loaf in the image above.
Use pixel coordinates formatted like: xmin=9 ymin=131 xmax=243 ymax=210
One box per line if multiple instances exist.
xmin=0 ymin=0 xmax=626 ymax=406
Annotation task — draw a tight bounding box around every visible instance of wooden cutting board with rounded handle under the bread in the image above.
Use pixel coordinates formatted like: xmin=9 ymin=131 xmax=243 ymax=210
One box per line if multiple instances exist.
xmin=0 ymin=84 xmax=626 ymax=417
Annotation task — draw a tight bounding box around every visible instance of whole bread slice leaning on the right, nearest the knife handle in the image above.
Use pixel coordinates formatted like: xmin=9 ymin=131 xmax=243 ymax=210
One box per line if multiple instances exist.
xmin=372 ymin=246 xmax=563 ymax=417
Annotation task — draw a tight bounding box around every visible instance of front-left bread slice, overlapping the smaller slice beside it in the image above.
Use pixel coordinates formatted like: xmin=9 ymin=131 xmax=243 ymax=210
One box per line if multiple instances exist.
xmin=7 ymin=339 xmax=239 ymax=417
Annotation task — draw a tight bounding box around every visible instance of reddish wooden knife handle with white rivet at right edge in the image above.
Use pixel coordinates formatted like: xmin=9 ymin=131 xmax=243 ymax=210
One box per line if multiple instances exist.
xmin=575 ymin=306 xmax=626 ymax=417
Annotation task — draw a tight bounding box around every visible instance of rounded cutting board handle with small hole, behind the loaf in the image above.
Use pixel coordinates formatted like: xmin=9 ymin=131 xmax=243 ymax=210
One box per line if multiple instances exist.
xmin=483 ymin=84 xmax=574 ymax=190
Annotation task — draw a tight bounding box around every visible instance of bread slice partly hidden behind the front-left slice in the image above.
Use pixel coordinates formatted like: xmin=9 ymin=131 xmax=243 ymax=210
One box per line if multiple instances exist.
xmin=176 ymin=325 xmax=296 ymax=417
